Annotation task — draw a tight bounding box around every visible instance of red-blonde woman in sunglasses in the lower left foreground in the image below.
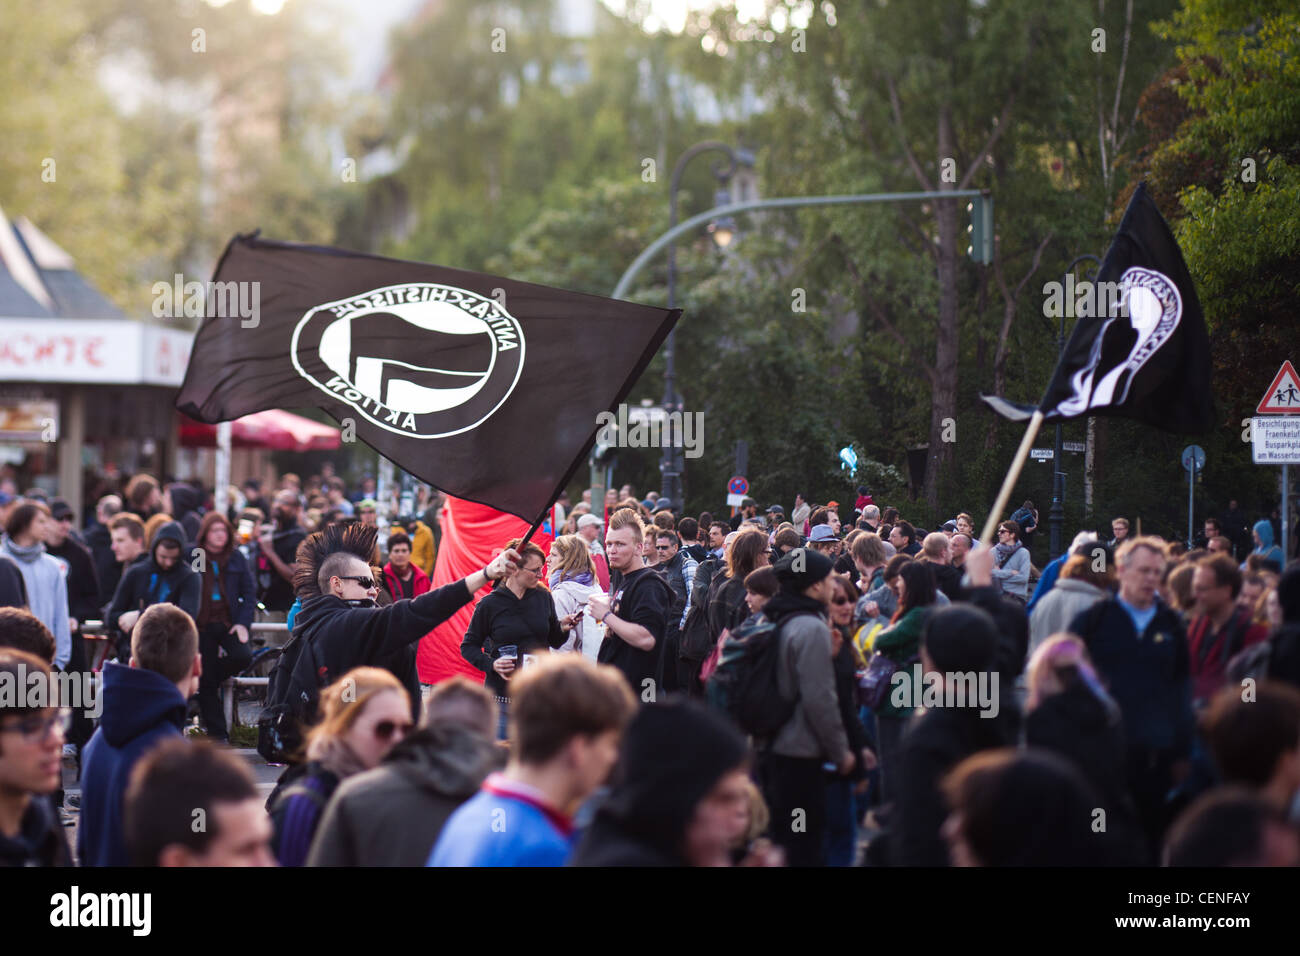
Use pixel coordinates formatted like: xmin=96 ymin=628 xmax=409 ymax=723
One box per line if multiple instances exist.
xmin=268 ymin=667 xmax=413 ymax=866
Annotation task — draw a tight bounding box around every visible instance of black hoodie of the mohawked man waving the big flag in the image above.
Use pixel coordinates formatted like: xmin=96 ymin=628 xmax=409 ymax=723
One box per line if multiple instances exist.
xmin=294 ymin=580 xmax=473 ymax=718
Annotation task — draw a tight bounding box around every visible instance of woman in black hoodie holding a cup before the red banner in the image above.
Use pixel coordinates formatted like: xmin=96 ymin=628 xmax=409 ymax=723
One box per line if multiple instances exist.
xmin=460 ymin=538 xmax=579 ymax=740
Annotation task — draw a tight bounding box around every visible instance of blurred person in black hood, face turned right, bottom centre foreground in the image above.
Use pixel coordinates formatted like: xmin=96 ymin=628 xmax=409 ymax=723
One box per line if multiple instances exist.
xmin=569 ymin=698 xmax=749 ymax=866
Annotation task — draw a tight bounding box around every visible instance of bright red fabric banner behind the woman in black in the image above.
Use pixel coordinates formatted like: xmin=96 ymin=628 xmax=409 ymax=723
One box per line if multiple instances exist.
xmin=416 ymin=496 xmax=554 ymax=684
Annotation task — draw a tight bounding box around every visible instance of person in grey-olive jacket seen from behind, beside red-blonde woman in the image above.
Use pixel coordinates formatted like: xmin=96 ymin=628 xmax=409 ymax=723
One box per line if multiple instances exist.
xmin=307 ymin=676 xmax=504 ymax=866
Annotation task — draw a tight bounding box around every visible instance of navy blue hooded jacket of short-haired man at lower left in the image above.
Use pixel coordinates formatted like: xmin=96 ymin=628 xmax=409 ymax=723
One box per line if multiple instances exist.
xmin=77 ymin=663 xmax=186 ymax=866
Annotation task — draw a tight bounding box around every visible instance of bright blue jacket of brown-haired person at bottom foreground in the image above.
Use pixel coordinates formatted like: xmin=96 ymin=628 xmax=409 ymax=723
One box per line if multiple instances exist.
xmin=425 ymin=774 xmax=575 ymax=866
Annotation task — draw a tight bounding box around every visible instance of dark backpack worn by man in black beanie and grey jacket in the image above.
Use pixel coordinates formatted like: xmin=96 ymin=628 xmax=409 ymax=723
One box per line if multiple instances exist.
xmin=705 ymin=614 xmax=798 ymax=740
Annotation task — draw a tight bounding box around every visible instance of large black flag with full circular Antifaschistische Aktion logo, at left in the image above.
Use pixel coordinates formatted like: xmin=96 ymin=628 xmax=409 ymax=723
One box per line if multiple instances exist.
xmin=176 ymin=234 xmax=681 ymax=522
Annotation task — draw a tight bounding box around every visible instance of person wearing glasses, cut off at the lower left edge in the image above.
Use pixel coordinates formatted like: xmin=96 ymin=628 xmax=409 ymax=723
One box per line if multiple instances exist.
xmin=0 ymin=650 xmax=72 ymax=866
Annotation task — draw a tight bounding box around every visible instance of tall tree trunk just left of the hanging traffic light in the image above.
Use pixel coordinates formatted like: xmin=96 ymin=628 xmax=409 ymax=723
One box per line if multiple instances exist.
xmin=926 ymin=107 xmax=961 ymax=514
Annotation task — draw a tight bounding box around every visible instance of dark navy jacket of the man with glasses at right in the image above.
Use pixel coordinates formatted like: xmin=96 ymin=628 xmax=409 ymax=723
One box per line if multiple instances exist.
xmin=1070 ymin=597 xmax=1195 ymax=757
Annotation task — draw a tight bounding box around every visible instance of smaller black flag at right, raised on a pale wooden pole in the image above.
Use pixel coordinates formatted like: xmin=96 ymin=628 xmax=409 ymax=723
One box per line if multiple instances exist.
xmin=982 ymin=183 xmax=1214 ymax=432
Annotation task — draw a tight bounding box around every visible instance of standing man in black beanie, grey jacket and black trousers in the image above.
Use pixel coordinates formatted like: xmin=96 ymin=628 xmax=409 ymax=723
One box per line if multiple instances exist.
xmin=759 ymin=548 xmax=857 ymax=866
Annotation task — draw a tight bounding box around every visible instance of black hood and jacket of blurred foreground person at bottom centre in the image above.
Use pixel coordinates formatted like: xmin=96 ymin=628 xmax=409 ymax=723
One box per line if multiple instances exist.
xmin=568 ymin=698 xmax=749 ymax=866
